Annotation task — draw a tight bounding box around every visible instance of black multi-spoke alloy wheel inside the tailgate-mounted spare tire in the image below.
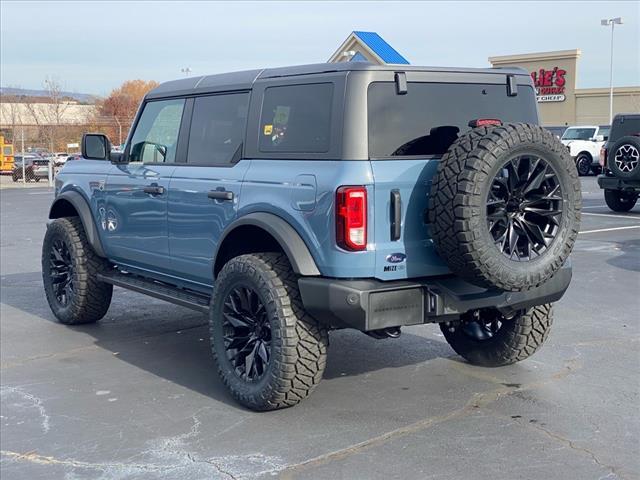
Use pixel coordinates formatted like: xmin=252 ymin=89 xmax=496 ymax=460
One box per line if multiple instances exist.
xmin=487 ymin=155 xmax=563 ymax=262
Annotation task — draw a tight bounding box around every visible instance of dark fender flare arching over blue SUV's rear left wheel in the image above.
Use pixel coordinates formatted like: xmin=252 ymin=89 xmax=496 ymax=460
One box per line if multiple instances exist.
xmin=213 ymin=212 xmax=320 ymax=276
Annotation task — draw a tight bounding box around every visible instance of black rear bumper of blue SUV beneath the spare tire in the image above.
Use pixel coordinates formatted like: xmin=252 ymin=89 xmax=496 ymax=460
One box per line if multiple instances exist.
xmin=298 ymin=264 xmax=571 ymax=331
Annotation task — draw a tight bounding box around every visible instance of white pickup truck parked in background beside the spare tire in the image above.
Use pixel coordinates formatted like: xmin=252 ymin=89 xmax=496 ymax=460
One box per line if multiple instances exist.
xmin=561 ymin=125 xmax=611 ymax=175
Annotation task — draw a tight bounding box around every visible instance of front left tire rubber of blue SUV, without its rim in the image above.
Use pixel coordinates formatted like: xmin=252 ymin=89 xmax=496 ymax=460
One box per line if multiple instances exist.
xmin=42 ymin=217 xmax=113 ymax=325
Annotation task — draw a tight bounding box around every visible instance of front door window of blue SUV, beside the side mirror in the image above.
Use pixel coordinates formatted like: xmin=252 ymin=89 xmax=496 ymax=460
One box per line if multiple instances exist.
xmin=129 ymin=98 xmax=185 ymax=163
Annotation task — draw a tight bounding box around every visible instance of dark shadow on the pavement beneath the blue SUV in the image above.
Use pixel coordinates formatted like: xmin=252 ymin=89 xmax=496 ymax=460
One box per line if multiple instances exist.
xmin=0 ymin=272 xmax=452 ymax=402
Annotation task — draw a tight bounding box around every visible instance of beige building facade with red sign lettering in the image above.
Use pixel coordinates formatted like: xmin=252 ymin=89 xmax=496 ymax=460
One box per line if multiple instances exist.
xmin=489 ymin=49 xmax=640 ymax=126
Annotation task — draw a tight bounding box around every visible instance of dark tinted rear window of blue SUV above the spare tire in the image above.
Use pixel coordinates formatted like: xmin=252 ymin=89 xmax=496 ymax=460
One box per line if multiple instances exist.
xmin=368 ymin=82 xmax=538 ymax=158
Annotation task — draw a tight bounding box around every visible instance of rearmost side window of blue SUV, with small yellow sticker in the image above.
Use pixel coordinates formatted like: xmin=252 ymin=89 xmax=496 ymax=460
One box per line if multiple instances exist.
xmin=259 ymin=83 xmax=333 ymax=153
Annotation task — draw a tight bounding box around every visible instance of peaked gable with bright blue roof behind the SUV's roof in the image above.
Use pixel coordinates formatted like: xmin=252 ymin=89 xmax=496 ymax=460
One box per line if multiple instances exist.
xmin=329 ymin=31 xmax=409 ymax=65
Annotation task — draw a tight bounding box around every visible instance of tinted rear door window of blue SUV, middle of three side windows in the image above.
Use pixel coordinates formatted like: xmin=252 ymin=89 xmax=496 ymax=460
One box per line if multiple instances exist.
xmin=187 ymin=93 xmax=249 ymax=165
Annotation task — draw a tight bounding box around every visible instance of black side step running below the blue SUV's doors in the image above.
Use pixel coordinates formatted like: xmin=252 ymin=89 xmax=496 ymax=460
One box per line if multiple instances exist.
xmin=98 ymin=271 xmax=210 ymax=313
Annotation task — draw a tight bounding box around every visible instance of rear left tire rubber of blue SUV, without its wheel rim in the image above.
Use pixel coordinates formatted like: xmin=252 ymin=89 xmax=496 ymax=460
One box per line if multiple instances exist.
xmin=209 ymin=253 xmax=329 ymax=411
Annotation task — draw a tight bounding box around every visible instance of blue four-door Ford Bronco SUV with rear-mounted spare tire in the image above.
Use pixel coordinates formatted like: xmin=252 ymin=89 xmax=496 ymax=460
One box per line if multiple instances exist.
xmin=42 ymin=63 xmax=581 ymax=410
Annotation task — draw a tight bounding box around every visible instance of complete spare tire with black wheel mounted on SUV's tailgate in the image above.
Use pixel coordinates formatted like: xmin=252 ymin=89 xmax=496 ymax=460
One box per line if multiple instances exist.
xmin=429 ymin=124 xmax=581 ymax=291
